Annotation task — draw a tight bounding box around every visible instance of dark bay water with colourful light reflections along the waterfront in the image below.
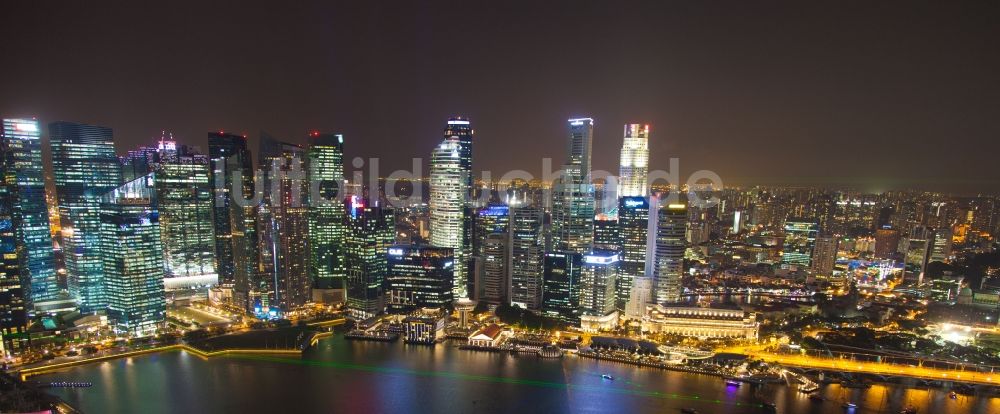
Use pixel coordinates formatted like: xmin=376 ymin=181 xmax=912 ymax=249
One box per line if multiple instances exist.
xmin=34 ymin=335 xmax=1000 ymax=414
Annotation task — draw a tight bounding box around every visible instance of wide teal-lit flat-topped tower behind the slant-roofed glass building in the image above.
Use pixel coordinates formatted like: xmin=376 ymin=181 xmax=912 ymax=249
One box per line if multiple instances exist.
xmin=49 ymin=122 xmax=122 ymax=313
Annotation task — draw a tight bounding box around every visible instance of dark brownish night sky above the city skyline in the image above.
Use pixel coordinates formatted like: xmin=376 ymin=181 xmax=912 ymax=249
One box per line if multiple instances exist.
xmin=0 ymin=1 xmax=1000 ymax=192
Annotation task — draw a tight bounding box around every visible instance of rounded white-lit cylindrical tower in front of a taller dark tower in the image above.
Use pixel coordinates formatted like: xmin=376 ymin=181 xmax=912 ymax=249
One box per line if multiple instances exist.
xmin=430 ymin=129 xmax=471 ymax=298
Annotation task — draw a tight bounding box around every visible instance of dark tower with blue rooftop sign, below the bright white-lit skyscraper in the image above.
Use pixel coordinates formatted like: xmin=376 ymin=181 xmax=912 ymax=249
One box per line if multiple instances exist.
xmin=616 ymin=196 xmax=649 ymax=311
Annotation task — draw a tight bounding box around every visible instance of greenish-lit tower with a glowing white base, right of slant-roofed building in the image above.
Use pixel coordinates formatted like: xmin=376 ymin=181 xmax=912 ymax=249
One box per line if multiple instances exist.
xmin=154 ymin=146 xmax=219 ymax=290
